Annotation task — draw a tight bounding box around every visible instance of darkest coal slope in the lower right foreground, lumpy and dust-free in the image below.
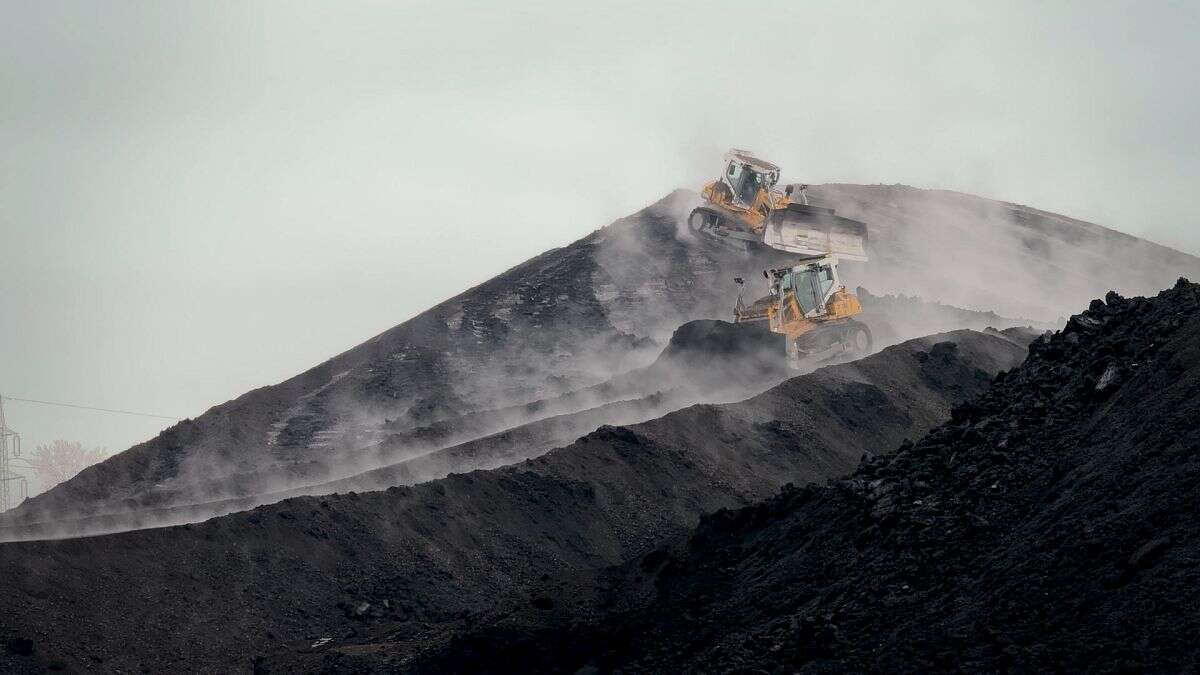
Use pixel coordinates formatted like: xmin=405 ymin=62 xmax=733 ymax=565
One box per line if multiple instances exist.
xmin=418 ymin=280 xmax=1200 ymax=673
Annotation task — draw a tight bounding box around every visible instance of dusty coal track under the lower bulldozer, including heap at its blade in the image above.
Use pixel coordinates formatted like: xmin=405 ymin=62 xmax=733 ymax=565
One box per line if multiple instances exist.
xmin=0 ymin=302 xmax=1038 ymax=542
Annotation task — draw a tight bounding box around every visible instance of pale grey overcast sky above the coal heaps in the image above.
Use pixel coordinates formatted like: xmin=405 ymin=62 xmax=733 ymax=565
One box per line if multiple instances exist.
xmin=0 ymin=0 xmax=1200 ymax=487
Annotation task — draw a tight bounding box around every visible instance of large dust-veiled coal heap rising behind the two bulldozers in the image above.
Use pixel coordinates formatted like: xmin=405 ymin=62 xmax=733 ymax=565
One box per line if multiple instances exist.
xmin=7 ymin=185 xmax=1200 ymax=525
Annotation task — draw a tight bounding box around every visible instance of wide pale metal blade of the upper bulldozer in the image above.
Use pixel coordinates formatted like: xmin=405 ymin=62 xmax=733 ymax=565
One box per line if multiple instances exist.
xmin=762 ymin=204 xmax=866 ymax=262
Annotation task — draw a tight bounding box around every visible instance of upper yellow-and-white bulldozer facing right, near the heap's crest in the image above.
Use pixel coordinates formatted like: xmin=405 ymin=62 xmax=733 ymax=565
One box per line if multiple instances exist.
xmin=688 ymin=149 xmax=866 ymax=262
